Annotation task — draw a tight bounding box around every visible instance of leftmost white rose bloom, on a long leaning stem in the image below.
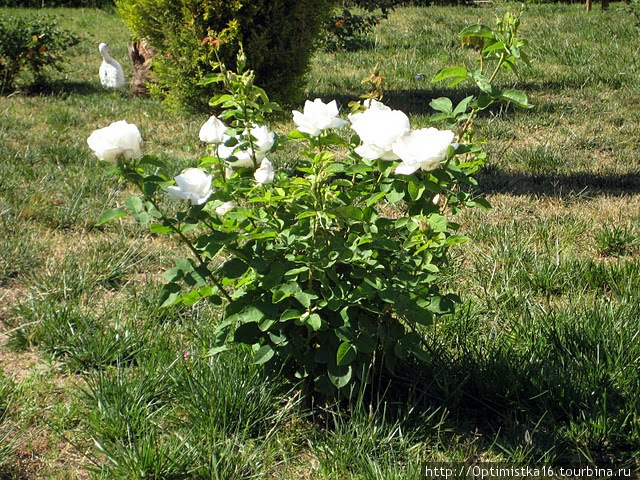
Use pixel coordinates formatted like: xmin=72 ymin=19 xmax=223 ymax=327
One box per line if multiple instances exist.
xmin=87 ymin=120 xmax=142 ymax=163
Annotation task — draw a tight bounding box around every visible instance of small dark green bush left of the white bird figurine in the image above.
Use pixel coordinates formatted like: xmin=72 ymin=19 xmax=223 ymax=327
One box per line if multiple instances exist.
xmin=0 ymin=15 xmax=78 ymax=91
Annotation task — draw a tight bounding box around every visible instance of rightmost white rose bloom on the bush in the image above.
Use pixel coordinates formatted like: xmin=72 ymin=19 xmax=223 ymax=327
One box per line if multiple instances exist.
xmin=393 ymin=127 xmax=454 ymax=175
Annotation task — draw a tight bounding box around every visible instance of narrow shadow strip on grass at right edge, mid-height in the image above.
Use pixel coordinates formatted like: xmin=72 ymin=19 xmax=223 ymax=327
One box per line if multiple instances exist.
xmin=477 ymin=166 xmax=640 ymax=197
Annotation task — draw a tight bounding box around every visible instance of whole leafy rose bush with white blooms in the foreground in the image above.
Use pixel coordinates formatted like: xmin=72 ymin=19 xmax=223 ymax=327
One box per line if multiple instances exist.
xmin=89 ymin=18 xmax=528 ymax=396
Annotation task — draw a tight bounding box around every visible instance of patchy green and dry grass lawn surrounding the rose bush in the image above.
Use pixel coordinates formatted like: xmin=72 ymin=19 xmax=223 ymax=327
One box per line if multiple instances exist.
xmin=0 ymin=4 xmax=640 ymax=480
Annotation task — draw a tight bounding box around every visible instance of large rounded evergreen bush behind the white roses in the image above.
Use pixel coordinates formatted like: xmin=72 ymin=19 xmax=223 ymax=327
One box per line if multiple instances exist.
xmin=116 ymin=0 xmax=335 ymax=110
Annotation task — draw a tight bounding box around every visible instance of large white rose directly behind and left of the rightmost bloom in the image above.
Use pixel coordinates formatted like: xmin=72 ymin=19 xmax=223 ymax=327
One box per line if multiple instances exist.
xmin=349 ymin=100 xmax=411 ymax=160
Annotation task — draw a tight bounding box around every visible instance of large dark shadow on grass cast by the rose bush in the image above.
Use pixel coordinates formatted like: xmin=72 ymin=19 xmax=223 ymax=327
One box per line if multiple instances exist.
xmin=358 ymin=332 xmax=640 ymax=469
